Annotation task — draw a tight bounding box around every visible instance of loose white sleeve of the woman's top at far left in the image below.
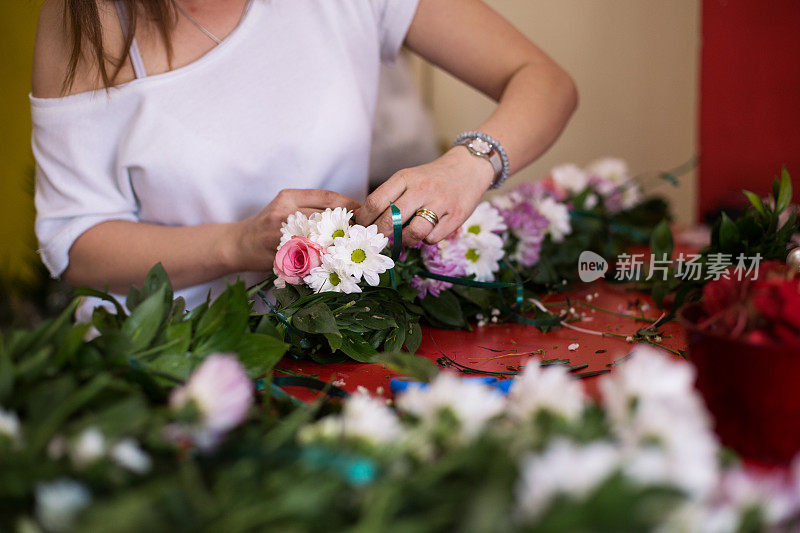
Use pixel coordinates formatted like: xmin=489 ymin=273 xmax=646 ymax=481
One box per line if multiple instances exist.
xmin=31 ymin=95 xmax=137 ymax=277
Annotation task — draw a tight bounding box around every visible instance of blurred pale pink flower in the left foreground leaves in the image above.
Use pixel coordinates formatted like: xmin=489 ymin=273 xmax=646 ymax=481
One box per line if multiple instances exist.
xmin=170 ymin=354 xmax=253 ymax=448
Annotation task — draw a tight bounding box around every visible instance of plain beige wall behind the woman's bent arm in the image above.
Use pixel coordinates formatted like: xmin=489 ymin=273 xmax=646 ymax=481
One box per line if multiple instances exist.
xmin=416 ymin=0 xmax=700 ymax=223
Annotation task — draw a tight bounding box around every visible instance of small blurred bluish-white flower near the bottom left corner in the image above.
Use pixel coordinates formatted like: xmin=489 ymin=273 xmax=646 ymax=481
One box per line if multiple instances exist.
xmin=36 ymin=479 xmax=92 ymax=531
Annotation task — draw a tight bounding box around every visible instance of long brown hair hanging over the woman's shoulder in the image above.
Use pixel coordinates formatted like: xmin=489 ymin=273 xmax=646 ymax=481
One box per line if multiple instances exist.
xmin=63 ymin=0 xmax=176 ymax=93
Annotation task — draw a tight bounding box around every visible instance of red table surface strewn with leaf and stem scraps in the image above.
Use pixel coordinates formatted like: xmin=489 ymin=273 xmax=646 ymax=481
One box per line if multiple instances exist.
xmin=278 ymin=280 xmax=686 ymax=400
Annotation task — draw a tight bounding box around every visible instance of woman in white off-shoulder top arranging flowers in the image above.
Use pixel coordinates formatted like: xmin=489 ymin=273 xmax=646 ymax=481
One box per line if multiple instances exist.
xmin=31 ymin=0 xmax=577 ymax=306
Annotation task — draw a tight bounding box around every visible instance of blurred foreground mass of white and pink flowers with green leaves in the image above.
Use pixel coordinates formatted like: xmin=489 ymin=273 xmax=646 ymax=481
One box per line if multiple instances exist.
xmin=0 ymin=282 xmax=800 ymax=532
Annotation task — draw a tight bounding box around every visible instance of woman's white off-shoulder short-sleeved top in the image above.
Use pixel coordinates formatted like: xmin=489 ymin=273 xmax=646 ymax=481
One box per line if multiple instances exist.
xmin=30 ymin=0 xmax=418 ymax=307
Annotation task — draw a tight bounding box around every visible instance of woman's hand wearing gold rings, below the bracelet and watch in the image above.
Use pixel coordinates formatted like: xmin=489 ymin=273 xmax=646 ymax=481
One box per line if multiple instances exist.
xmin=355 ymin=146 xmax=494 ymax=246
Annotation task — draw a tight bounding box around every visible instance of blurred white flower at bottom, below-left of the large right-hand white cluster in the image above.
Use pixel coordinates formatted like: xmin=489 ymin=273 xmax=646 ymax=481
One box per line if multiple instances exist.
xmin=517 ymin=439 xmax=620 ymax=518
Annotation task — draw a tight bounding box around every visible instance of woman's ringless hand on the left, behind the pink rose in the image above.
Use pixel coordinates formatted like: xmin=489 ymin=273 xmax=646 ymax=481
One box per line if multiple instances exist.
xmin=231 ymin=189 xmax=361 ymax=272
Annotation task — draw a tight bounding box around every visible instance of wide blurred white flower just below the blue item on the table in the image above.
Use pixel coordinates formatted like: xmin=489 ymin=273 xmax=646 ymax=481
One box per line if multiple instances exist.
xmin=397 ymin=372 xmax=505 ymax=438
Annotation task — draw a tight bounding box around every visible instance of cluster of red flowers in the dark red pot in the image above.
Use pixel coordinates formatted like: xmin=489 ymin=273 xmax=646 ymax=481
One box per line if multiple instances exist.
xmin=697 ymin=261 xmax=800 ymax=344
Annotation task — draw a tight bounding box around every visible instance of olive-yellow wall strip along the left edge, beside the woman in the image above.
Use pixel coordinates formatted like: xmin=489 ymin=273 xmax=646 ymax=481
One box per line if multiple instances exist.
xmin=0 ymin=0 xmax=40 ymax=277
